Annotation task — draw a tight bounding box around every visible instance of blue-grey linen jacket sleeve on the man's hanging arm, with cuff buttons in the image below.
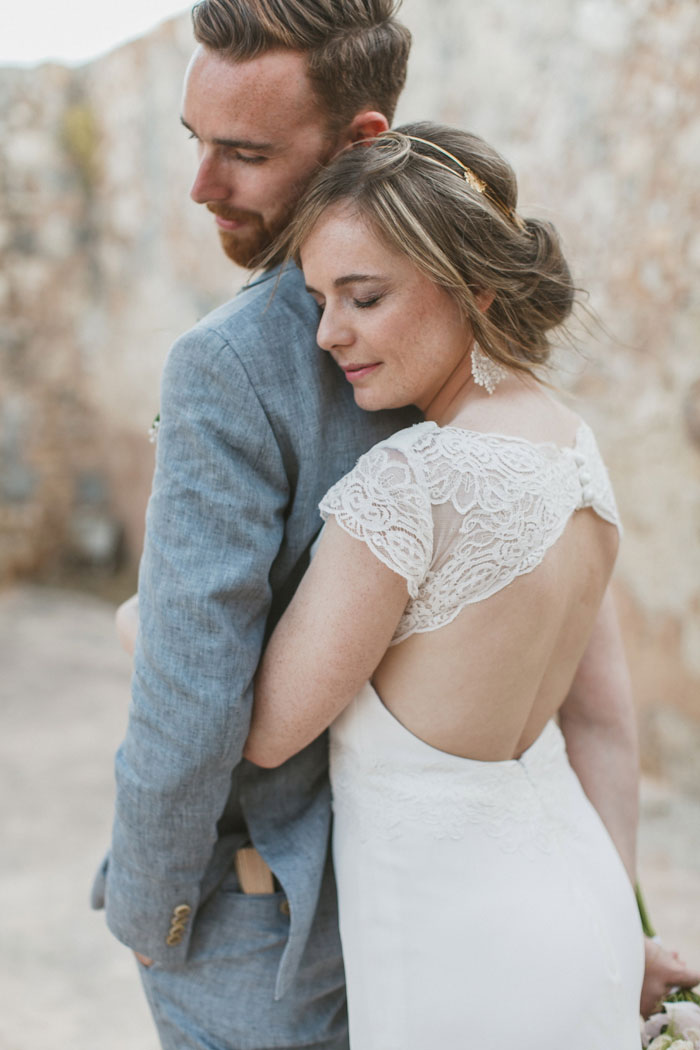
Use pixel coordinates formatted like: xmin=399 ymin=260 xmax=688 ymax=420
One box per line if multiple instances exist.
xmin=105 ymin=329 xmax=288 ymax=968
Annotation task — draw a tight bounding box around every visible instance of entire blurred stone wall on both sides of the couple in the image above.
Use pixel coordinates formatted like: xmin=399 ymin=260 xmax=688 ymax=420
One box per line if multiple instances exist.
xmin=0 ymin=0 xmax=700 ymax=793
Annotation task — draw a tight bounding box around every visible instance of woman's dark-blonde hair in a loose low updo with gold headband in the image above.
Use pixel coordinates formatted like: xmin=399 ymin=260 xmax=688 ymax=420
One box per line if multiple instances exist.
xmin=284 ymin=122 xmax=575 ymax=378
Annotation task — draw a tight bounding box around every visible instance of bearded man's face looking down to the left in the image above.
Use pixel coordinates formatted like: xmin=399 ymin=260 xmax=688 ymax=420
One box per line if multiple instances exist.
xmin=183 ymin=46 xmax=331 ymax=266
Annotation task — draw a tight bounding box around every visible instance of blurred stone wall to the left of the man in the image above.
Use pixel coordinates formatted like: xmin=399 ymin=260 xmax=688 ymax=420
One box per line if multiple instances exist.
xmin=0 ymin=19 xmax=238 ymax=582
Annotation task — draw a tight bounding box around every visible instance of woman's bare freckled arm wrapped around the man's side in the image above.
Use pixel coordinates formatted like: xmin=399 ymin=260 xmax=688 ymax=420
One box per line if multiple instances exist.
xmin=243 ymin=518 xmax=408 ymax=767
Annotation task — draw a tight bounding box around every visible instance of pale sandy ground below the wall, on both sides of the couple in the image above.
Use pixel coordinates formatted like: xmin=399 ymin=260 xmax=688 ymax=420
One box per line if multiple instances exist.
xmin=0 ymin=587 xmax=700 ymax=1050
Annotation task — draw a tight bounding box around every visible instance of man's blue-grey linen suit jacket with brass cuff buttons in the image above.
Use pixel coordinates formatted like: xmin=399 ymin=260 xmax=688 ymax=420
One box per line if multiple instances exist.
xmin=93 ymin=266 xmax=417 ymax=998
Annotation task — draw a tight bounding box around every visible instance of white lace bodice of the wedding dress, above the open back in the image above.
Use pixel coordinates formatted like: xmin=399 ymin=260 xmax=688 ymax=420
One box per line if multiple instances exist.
xmin=320 ymin=422 xmax=620 ymax=645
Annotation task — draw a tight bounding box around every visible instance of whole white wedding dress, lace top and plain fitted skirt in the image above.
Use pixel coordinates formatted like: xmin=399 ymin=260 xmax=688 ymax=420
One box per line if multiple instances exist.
xmin=321 ymin=422 xmax=643 ymax=1050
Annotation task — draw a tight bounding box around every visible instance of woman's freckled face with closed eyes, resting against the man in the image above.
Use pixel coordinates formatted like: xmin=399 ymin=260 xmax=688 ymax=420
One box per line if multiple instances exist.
xmin=301 ymin=203 xmax=471 ymax=411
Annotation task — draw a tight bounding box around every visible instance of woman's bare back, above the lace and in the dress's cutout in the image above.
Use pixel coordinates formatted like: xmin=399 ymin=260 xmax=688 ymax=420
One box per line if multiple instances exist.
xmin=373 ymin=383 xmax=618 ymax=761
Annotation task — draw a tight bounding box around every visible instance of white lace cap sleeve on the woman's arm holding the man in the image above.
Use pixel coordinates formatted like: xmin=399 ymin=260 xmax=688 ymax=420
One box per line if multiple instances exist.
xmin=319 ymin=445 xmax=432 ymax=597
